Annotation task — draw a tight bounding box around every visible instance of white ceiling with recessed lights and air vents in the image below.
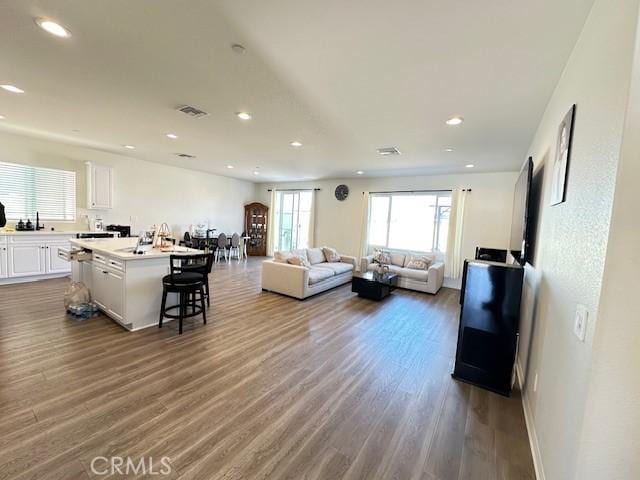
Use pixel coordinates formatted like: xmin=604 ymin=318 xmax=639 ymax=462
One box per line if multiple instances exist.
xmin=0 ymin=0 xmax=593 ymax=181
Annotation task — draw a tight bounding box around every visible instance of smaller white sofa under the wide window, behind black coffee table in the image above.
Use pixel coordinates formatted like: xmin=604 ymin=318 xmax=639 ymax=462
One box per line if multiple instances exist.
xmin=360 ymin=252 xmax=444 ymax=295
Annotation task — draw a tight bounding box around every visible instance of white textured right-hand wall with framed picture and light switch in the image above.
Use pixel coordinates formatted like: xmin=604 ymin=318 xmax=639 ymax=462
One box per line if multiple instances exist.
xmin=518 ymin=0 xmax=638 ymax=480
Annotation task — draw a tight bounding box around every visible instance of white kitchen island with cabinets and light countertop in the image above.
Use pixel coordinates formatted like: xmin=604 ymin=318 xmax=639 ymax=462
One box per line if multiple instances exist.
xmin=70 ymin=238 xmax=202 ymax=331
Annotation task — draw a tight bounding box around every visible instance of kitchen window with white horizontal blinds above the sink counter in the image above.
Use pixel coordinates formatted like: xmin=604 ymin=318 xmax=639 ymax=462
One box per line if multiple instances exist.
xmin=0 ymin=162 xmax=76 ymax=222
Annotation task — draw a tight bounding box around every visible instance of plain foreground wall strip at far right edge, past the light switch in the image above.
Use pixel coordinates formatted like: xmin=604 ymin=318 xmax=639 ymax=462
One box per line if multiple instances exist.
xmin=576 ymin=16 xmax=640 ymax=480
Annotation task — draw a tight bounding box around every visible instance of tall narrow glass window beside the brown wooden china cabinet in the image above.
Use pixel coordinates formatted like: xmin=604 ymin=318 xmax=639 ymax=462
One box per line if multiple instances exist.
xmin=275 ymin=190 xmax=313 ymax=251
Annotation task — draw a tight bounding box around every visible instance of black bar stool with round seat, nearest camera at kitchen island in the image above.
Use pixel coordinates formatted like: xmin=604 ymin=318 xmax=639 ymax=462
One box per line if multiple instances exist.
xmin=158 ymin=255 xmax=207 ymax=335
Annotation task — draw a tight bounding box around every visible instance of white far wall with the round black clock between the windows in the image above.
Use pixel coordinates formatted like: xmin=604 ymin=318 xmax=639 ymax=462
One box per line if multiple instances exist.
xmin=256 ymin=170 xmax=524 ymax=282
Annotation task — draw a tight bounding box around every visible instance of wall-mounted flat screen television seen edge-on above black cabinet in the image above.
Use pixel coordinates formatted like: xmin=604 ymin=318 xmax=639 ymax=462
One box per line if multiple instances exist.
xmin=509 ymin=157 xmax=533 ymax=265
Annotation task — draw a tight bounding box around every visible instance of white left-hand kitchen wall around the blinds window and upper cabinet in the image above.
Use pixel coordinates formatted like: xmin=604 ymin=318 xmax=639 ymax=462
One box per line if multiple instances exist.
xmin=0 ymin=133 xmax=254 ymax=235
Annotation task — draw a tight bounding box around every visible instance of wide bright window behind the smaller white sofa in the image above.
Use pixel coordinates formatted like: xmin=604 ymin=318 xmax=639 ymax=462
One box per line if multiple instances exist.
xmin=368 ymin=192 xmax=451 ymax=252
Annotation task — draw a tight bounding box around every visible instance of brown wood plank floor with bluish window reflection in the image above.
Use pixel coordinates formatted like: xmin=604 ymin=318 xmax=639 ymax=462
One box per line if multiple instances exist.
xmin=0 ymin=259 xmax=534 ymax=480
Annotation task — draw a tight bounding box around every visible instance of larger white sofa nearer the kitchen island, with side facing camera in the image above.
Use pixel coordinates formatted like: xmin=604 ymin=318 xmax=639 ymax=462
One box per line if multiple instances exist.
xmin=262 ymin=248 xmax=358 ymax=300
